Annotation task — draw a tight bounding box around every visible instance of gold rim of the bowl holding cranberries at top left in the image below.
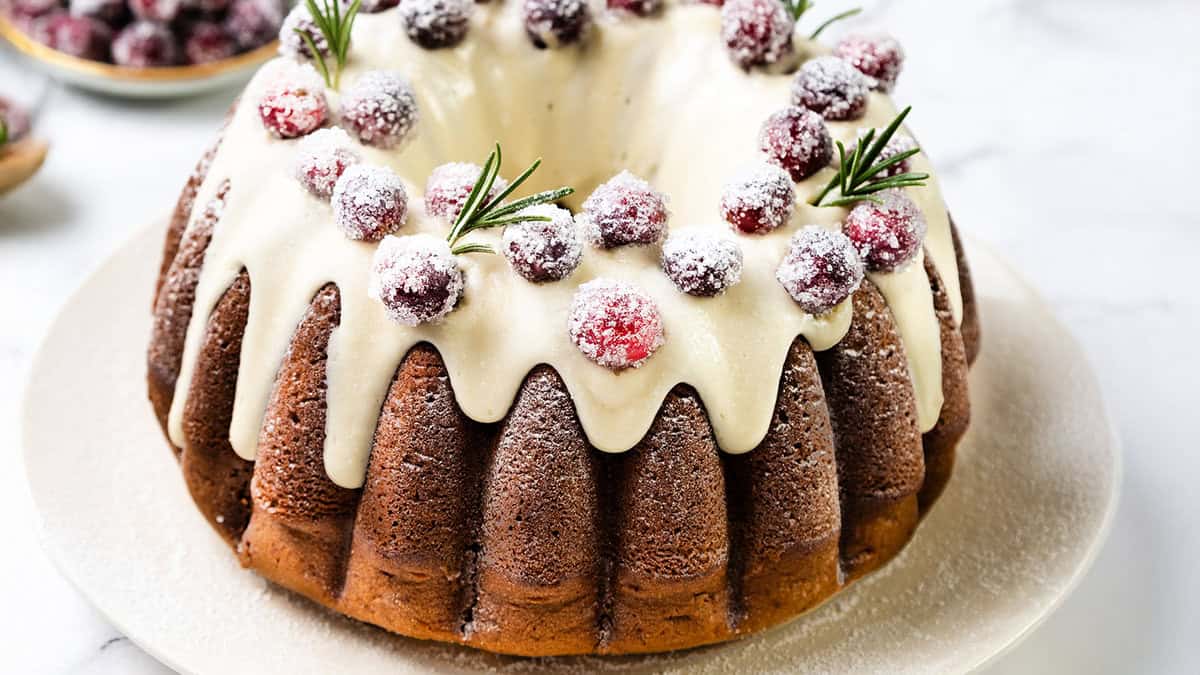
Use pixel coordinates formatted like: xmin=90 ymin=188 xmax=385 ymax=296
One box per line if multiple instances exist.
xmin=0 ymin=16 xmax=278 ymax=82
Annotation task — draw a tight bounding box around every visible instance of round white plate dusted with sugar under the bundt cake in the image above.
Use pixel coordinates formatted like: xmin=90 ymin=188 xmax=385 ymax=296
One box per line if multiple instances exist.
xmin=23 ymin=218 xmax=1121 ymax=674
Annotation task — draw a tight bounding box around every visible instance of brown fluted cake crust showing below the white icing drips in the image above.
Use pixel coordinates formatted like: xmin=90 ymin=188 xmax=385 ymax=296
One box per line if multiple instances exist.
xmin=149 ymin=166 xmax=978 ymax=656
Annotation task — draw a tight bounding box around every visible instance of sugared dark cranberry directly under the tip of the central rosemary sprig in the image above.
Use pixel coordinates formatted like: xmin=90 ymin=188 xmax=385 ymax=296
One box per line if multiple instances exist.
xmin=500 ymin=204 xmax=583 ymax=282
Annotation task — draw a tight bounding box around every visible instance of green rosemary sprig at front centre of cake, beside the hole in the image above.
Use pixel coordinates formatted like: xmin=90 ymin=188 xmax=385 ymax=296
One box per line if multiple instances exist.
xmin=446 ymin=143 xmax=575 ymax=255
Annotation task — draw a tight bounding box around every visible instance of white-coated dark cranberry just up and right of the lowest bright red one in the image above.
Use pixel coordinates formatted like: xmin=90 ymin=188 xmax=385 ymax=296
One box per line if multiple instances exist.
xmin=662 ymin=232 xmax=742 ymax=298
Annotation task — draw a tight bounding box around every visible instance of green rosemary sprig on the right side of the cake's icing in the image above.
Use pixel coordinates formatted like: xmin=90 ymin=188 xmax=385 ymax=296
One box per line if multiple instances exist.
xmin=809 ymin=106 xmax=929 ymax=207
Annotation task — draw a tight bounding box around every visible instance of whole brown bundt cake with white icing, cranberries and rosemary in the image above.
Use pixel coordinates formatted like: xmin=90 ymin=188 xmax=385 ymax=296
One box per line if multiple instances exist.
xmin=148 ymin=0 xmax=979 ymax=655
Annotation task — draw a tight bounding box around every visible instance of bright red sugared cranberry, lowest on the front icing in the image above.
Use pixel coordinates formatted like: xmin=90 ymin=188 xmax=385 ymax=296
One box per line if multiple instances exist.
xmin=568 ymin=279 xmax=665 ymax=370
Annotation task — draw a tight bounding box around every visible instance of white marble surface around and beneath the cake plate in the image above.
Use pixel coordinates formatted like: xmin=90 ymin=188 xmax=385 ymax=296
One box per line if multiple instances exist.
xmin=0 ymin=0 xmax=1200 ymax=674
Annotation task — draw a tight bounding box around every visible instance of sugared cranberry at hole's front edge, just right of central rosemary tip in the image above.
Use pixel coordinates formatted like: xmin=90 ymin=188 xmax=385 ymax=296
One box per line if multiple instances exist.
xmin=578 ymin=171 xmax=667 ymax=249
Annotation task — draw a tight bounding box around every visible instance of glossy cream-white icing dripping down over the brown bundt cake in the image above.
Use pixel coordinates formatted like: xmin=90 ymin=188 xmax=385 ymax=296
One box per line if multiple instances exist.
xmin=169 ymin=2 xmax=961 ymax=488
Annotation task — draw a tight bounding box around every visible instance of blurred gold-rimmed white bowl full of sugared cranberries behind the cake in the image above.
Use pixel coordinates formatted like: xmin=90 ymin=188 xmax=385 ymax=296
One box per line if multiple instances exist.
xmin=0 ymin=0 xmax=289 ymax=97
